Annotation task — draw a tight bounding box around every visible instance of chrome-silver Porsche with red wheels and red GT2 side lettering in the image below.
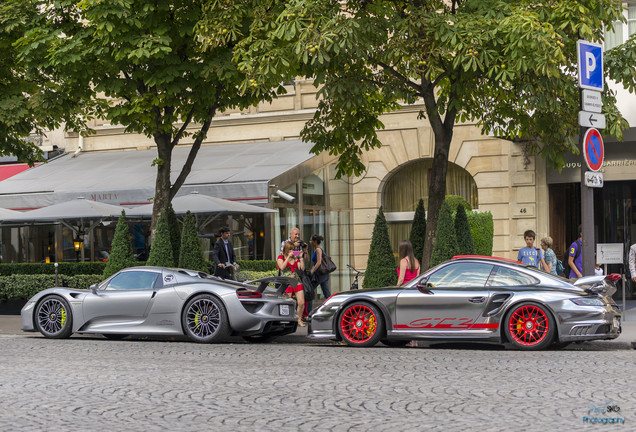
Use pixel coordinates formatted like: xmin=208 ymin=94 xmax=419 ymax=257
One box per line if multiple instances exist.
xmin=308 ymin=256 xmax=621 ymax=350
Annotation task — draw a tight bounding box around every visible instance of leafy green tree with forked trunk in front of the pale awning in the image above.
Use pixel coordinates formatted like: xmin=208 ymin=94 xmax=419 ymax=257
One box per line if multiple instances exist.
xmin=0 ymin=0 xmax=287 ymax=233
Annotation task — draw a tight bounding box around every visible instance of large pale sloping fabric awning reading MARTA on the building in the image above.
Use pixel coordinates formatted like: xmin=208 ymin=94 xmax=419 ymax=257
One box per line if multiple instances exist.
xmin=0 ymin=140 xmax=314 ymax=210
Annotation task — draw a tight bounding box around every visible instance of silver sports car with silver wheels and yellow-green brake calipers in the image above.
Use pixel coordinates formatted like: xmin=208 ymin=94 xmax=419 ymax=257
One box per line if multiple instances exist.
xmin=21 ymin=267 xmax=298 ymax=343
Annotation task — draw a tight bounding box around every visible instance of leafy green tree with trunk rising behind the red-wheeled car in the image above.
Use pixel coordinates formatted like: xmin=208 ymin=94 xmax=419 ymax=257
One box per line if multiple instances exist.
xmin=238 ymin=0 xmax=636 ymax=268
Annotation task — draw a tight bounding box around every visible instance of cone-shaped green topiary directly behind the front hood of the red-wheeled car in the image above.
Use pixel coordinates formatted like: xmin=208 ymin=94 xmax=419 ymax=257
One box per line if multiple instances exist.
xmin=363 ymin=207 xmax=397 ymax=288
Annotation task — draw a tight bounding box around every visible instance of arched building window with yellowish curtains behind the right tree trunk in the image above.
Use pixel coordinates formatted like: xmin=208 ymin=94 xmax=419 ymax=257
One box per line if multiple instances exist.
xmin=382 ymin=159 xmax=478 ymax=255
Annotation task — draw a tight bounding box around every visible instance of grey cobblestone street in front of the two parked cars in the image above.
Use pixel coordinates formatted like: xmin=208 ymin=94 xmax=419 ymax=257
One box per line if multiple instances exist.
xmin=0 ymin=334 xmax=636 ymax=432
